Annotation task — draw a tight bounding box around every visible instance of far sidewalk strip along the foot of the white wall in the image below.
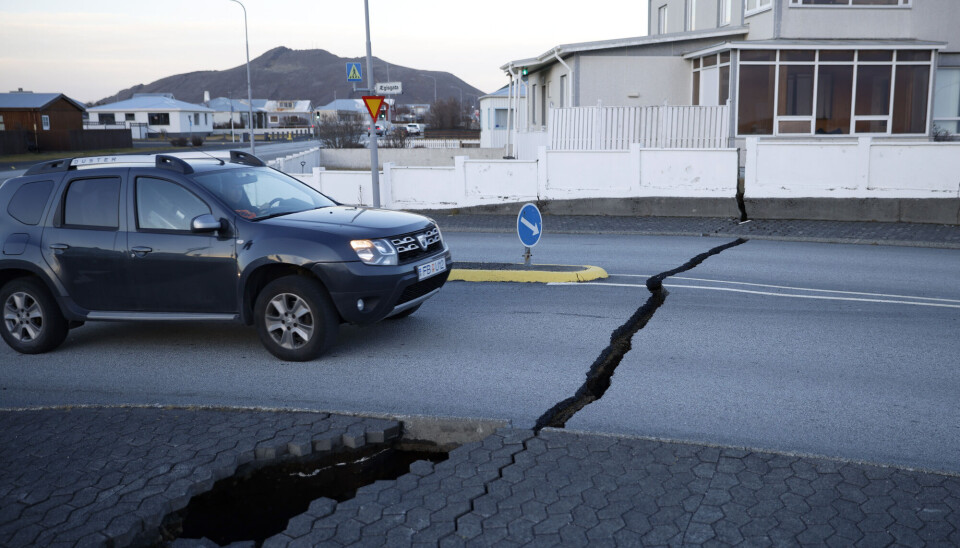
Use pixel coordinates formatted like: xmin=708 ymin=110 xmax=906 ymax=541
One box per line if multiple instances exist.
xmin=421 ymin=211 xmax=960 ymax=249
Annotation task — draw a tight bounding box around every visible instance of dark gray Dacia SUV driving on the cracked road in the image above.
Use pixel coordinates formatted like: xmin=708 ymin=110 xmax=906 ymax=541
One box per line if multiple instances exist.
xmin=0 ymin=151 xmax=451 ymax=361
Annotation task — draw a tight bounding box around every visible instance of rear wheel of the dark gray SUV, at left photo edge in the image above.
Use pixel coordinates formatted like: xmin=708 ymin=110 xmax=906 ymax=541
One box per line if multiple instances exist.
xmin=0 ymin=278 xmax=70 ymax=354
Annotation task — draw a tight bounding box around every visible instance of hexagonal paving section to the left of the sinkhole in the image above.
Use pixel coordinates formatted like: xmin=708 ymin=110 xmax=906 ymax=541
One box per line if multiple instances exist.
xmin=0 ymin=408 xmax=400 ymax=548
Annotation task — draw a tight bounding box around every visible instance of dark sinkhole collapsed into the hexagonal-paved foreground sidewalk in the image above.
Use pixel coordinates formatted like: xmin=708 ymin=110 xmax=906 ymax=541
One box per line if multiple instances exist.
xmin=161 ymin=443 xmax=447 ymax=546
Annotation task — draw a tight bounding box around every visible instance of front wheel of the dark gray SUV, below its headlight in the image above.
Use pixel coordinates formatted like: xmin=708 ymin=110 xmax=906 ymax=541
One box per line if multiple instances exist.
xmin=254 ymin=276 xmax=340 ymax=362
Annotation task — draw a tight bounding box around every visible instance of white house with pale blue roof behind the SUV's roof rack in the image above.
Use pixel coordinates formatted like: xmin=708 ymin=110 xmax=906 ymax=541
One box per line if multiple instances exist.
xmin=87 ymin=93 xmax=214 ymax=138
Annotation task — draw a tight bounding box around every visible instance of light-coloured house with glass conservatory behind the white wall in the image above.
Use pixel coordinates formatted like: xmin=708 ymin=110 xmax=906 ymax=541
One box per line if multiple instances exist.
xmin=501 ymin=0 xmax=960 ymax=144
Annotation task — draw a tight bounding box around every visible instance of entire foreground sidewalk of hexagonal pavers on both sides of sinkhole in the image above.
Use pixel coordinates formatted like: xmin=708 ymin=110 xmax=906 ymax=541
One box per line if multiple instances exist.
xmin=0 ymin=408 xmax=960 ymax=547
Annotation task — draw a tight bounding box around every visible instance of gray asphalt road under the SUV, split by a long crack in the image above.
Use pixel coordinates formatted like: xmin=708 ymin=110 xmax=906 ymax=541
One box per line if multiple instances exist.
xmin=0 ymin=233 xmax=960 ymax=478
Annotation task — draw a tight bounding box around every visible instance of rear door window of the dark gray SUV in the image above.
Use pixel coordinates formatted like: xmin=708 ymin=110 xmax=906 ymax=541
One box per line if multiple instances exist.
xmin=63 ymin=177 xmax=120 ymax=229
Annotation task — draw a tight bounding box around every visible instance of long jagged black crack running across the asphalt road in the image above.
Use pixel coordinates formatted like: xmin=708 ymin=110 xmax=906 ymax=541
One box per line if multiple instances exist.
xmin=533 ymin=238 xmax=748 ymax=432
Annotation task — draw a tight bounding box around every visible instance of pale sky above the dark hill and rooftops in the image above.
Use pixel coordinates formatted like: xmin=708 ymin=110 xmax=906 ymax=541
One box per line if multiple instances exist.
xmin=0 ymin=0 xmax=647 ymax=102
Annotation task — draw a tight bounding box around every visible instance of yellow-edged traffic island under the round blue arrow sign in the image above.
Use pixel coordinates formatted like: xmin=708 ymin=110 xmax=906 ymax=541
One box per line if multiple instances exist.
xmin=449 ymin=261 xmax=607 ymax=283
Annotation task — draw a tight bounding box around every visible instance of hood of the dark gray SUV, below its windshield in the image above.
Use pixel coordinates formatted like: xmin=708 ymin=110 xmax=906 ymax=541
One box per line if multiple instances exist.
xmin=260 ymin=206 xmax=430 ymax=233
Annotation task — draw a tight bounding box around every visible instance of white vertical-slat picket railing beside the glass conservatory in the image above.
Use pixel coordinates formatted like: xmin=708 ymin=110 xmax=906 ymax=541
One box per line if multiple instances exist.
xmin=549 ymin=105 xmax=730 ymax=150
